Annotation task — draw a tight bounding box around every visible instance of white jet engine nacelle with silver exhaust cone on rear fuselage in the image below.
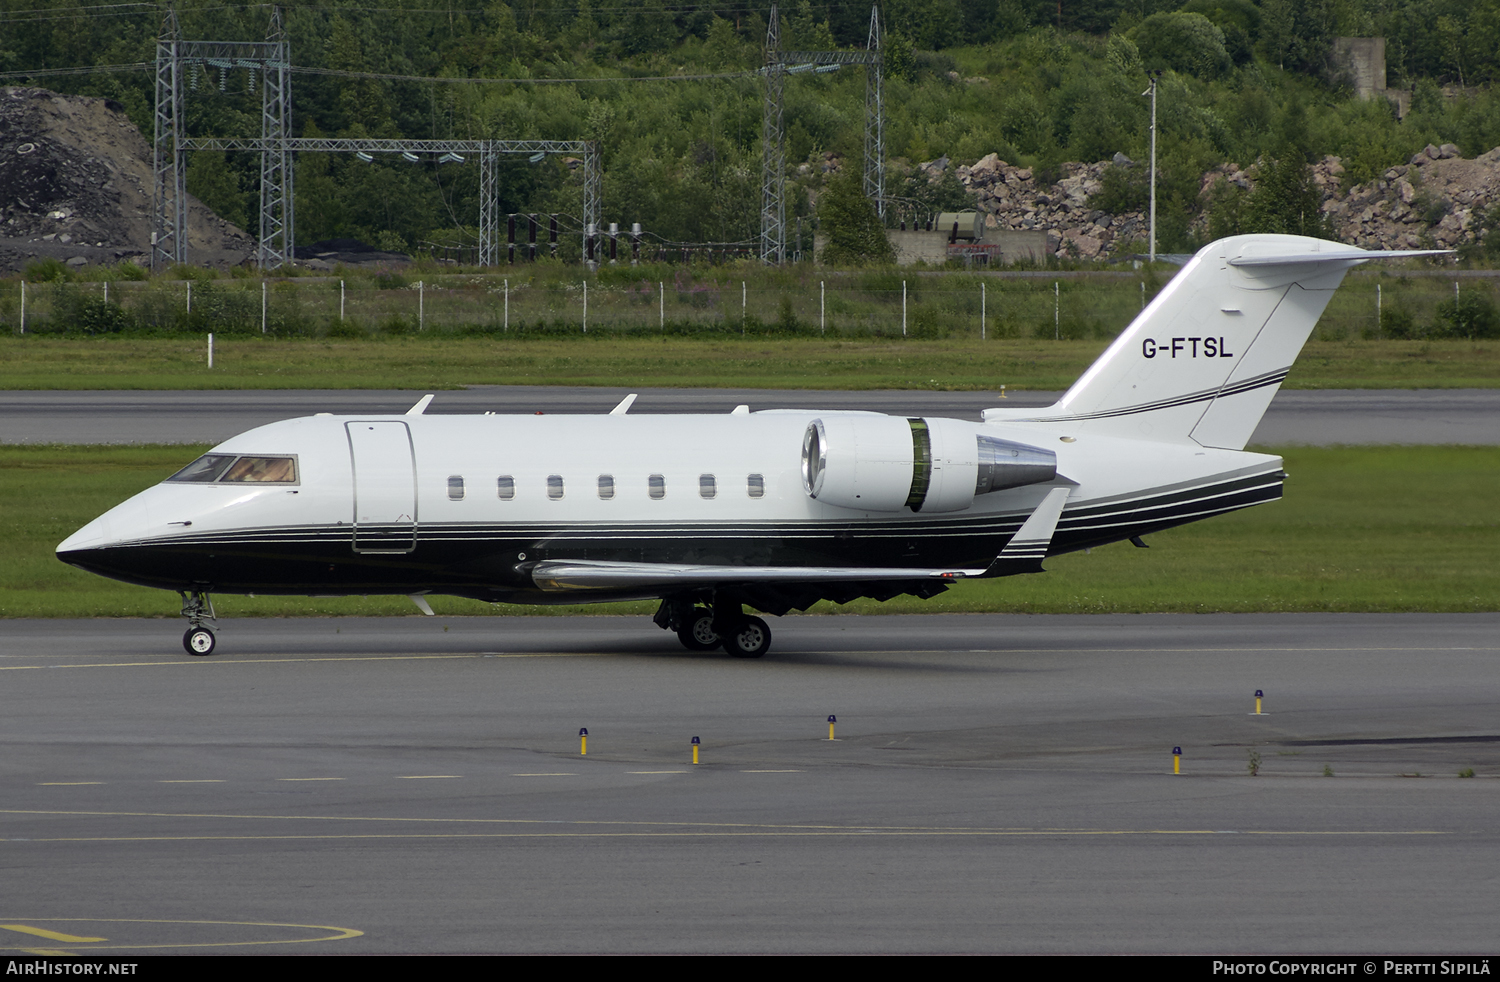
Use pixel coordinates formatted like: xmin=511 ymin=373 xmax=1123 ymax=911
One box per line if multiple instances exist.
xmin=803 ymin=415 xmax=1058 ymax=511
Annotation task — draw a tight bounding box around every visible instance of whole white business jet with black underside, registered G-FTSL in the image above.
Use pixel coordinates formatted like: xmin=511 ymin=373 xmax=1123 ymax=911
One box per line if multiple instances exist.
xmin=57 ymin=235 xmax=1431 ymax=658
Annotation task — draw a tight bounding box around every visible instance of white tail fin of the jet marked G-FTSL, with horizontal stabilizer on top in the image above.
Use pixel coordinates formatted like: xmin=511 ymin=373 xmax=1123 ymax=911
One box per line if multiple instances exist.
xmin=987 ymin=235 xmax=1434 ymax=450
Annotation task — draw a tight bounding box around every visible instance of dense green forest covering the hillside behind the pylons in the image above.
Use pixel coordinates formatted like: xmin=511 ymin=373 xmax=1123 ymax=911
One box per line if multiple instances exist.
xmin=0 ymin=0 xmax=1500 ymax=250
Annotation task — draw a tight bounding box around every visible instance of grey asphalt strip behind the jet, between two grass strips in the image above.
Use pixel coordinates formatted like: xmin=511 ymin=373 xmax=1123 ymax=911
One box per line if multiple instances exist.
xmin=0 ymin=385 xmax=1500 ymax=447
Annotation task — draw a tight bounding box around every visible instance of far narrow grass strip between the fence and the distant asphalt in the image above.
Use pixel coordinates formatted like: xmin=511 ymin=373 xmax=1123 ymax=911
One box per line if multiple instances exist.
xmin=0 ymin=333 xmax=1500 ymax=391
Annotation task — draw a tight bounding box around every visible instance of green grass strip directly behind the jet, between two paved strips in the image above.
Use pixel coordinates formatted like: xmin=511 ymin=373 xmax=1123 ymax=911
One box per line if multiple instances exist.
xmin=0 ymin=447 xmax=1500 ymax=618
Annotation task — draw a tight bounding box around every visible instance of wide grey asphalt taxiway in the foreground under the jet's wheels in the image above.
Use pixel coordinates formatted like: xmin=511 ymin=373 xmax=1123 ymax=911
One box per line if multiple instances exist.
xmin=0 ymin=615 xmax=1500 ymax=954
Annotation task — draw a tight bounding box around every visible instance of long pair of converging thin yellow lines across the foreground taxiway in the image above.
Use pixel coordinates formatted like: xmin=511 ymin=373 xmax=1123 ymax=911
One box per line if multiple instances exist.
xmin=0 ymin=809 xmax=1455 ymax=843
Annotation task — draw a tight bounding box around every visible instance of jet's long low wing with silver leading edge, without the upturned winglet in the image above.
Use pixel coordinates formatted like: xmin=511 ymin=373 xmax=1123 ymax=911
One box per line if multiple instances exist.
xmin=531 ymin=559 xmax=984 ymax=594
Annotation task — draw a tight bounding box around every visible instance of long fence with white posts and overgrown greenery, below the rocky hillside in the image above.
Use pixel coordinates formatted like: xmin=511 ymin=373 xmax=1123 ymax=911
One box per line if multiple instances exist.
xmin=0 ymin=270 xmax=1500 ymax=340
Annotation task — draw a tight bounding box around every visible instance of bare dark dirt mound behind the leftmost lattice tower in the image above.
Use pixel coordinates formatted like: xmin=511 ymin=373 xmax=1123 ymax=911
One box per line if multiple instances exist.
xmin=0 ymin=88 xmax=255 ymax=273
